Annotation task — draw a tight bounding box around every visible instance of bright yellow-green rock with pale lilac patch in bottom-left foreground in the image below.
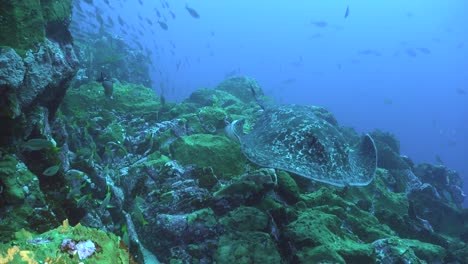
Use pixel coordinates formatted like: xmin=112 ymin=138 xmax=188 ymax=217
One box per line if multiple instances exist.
xmin=0 ymin=221 xmax=132 ymax=264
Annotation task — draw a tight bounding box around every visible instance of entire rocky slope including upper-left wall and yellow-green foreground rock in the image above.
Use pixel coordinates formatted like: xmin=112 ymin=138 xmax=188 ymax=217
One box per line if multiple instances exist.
xmin=0 ymin=0 xmax=468 ymax=263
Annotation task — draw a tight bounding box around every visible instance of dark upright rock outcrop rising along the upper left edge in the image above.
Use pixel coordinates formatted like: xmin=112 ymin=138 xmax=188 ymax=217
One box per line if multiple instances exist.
xmin=0 ymin=0 xmax=78 ymax=145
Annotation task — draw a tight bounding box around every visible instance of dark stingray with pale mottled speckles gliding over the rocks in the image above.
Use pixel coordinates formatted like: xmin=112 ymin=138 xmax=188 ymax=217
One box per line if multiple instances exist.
xmin=227 ymin=105 xmax=377 ymax=186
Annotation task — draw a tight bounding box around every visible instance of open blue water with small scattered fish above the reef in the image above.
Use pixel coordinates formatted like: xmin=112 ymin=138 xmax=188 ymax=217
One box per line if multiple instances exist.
xmin=71 ymin=0 xmax=468 ymax=206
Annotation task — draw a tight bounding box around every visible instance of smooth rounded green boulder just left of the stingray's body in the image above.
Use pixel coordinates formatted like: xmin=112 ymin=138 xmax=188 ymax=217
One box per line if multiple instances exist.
xmin=171 ymin=134 xmax=245 ymax=176
